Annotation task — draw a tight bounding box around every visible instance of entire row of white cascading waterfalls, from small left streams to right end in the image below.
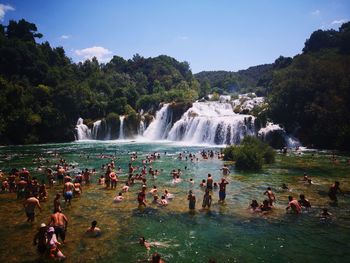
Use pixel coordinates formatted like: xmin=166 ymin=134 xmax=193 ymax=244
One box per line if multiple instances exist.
xmin=75 ymin=97 xmax=300 ymax=148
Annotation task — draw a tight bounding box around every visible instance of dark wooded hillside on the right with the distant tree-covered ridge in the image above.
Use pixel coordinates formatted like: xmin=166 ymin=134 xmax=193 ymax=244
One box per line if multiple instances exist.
xmin=195 ymin=22 xmax=350 ymax=150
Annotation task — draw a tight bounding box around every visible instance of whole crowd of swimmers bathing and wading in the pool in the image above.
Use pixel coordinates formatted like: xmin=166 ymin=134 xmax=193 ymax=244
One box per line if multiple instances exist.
xmin=0 ymin=150 xmax=348 ymax=262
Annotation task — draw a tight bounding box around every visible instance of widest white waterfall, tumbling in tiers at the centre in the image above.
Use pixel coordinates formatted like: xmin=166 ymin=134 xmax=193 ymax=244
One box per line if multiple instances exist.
xmin=167 ymin=102 xmax=255 ymax=144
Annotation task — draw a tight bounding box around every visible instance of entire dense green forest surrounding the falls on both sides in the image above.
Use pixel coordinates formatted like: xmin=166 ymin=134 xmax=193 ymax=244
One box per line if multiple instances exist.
xmin=0 ymin=19 xmax=350 ymax=150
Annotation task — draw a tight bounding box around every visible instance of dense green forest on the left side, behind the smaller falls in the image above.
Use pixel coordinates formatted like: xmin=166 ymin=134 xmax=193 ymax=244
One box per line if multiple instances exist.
xmin=0 ymin=19 xmax=204 ymax=144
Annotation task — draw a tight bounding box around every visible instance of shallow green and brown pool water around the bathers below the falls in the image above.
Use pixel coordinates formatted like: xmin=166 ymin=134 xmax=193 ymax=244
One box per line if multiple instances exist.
xmin=0 ymin=142 xmax=350 ymax=262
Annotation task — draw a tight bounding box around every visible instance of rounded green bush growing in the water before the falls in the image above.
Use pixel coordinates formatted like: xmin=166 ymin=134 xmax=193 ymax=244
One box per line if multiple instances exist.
xmin=224 ymin=136 xmax=275 ymax=171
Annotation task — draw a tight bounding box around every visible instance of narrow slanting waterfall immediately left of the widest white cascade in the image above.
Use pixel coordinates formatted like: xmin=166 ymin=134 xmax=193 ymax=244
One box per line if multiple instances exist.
xmin=143 ymin=104 xmax=172 ymax=140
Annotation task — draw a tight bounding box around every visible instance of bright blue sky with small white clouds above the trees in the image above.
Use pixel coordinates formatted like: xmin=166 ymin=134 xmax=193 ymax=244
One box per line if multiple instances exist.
xmin=0 ymin=0 xmax=350 ymax=73
